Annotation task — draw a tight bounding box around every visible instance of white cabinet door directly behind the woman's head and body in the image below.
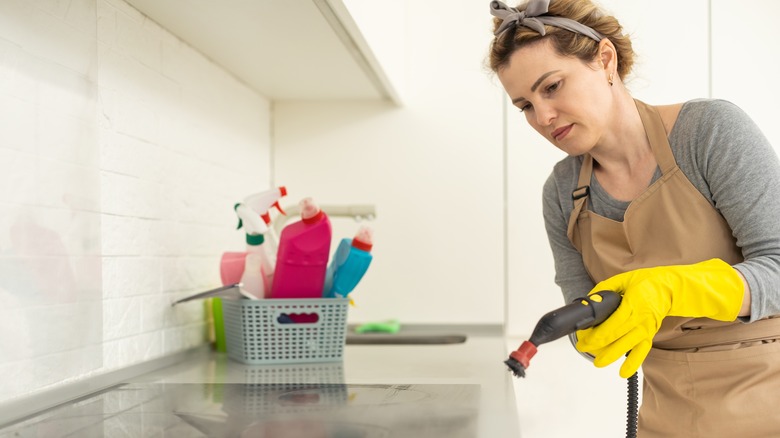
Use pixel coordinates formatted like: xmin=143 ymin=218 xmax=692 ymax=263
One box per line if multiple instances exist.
xmin=506 ymin=0 xmax=712 ymax=335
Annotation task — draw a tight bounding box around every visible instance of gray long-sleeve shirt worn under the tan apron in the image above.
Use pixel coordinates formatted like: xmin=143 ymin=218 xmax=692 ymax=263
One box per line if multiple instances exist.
xmin=543 ymin=99 xmax=780 ymax=321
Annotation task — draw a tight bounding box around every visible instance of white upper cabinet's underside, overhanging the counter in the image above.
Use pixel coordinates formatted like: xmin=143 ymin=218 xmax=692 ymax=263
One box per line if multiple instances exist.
xmin=127 ymin=0 xmax=398 ymax=102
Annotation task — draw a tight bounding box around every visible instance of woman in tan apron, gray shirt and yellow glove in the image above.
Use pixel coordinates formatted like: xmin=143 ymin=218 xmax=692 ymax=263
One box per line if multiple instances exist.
xmin=490 ymin=0 xmax=780 ymax=432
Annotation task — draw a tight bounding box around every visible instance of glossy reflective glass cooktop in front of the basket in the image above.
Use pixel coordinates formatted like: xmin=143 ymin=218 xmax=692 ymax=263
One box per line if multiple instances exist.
xmin=0 ymin=383 xmax=479 ymax=438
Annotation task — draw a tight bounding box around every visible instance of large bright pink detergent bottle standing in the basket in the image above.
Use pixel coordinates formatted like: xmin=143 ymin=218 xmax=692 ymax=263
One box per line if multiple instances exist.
xmin=271 ymin=198 xmax=333 ymax=298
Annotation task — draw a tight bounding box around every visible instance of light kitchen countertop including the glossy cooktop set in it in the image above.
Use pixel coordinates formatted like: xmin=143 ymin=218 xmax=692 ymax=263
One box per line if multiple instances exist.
xmin=0 ymin=332 xmax=520 ymax=438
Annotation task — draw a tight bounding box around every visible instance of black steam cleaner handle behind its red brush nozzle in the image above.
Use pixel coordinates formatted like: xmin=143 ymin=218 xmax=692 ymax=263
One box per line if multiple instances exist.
xmin=529 ymin=290 xmax=622 ymax=347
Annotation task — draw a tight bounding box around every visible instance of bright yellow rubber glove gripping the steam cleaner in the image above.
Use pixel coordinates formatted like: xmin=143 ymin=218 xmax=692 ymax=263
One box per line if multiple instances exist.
xmin=577 ymin=259 xmax=745 ymax=378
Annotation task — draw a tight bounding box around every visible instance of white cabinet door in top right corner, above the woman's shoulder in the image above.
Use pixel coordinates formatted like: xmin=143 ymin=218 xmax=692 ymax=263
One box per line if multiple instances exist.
xmin=712 ymin=0 xmax=780 ymax=152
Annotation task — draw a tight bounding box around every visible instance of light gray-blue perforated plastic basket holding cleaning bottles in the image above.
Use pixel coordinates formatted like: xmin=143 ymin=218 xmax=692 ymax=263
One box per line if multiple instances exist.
xmin=222 ymin=298 xmax=349 ymax=365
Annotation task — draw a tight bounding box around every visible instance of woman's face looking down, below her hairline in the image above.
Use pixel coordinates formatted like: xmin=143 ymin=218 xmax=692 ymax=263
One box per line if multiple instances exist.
xmin=498 ymin=40 xmax=612 ymax=155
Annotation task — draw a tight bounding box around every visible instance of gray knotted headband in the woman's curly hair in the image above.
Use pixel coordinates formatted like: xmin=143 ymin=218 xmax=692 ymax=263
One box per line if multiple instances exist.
xmin=490 ymin=0 xmax=604 ymax=42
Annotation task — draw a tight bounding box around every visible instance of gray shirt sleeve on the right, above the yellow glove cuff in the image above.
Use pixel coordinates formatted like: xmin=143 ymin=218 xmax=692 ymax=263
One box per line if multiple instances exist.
xmin=673 ymin=100 xmax=780 ymax=321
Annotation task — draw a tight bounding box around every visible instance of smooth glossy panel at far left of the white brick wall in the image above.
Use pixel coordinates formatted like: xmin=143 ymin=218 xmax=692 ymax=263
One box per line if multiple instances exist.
xmin=0 ymin=1 xmax=103 ymax=404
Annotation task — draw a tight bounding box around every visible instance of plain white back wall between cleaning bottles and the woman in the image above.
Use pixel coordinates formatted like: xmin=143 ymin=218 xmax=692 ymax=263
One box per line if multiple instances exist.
xmin=274 ymin=1 xmax=504 ymax=324
